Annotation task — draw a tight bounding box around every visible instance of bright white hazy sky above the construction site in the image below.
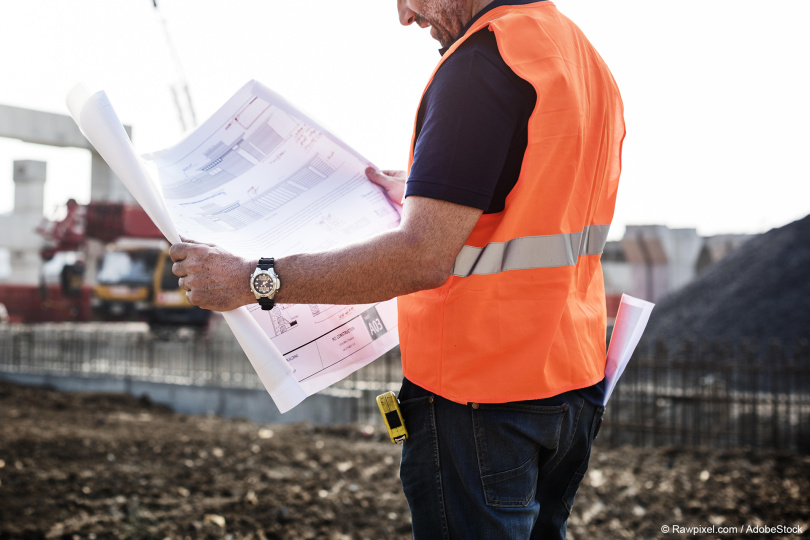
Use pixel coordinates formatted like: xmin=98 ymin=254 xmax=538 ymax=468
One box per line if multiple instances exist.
xmin=0 ymin=0 xmax=810 ymax=239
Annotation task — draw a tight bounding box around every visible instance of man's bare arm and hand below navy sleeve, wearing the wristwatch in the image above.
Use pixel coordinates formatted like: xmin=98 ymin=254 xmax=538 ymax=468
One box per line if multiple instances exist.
xmin=170 ymin=197 xmax=481 ymax=311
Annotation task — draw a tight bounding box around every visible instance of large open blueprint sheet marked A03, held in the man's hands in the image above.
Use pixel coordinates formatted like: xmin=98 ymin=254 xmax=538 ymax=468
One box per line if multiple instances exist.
xmin=68 ymin=81 xmax=400 ymax=412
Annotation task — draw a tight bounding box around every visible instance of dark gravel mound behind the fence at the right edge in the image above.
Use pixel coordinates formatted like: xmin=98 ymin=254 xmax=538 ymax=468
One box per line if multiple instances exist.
xmin=645 ymin=215 xmax=810 ymax=347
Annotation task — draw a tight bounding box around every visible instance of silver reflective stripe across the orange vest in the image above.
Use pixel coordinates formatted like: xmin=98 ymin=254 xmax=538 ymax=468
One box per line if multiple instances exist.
xmin=451 ymin=225 xmax=610 ymax=277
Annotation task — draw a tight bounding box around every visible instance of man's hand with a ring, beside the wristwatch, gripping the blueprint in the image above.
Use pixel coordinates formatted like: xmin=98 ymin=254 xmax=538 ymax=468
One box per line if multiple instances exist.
xmin=169 ymin=238 xmax=256 ymax=311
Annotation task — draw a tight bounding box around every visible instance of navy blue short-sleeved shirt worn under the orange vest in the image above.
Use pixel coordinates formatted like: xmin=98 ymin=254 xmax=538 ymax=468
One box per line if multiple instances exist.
xmin=405 ymin=0 xmax=604 ymax=405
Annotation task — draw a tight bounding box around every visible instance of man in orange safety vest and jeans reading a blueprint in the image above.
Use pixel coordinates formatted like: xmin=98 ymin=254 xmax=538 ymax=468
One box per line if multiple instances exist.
xmin=171 ymin=0 xmax=624 ymax=539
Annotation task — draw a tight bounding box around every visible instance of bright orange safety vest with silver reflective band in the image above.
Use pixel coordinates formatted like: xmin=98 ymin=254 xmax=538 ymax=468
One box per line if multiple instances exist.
xmin=398 ymin=1 xmax=625 ymax=403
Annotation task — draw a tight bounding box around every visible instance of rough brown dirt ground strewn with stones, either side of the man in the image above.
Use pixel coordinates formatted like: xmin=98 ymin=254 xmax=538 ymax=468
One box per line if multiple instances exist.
xmin=0 ymin=381 xmax=810 ymax=540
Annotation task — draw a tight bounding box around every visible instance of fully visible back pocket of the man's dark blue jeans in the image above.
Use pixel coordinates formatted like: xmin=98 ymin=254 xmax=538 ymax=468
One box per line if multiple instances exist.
xmin=472 ymin=402 xmax=570 ymax=507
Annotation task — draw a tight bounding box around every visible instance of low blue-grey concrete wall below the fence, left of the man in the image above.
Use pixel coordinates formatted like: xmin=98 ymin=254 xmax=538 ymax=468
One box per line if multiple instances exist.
xmin=0 ymin=372 xmax=356 ymax=425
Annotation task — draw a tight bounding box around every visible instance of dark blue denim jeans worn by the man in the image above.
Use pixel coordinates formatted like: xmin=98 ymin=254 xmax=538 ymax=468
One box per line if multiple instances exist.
xmin=399 ymin=379 xmax=604 ymax=540
